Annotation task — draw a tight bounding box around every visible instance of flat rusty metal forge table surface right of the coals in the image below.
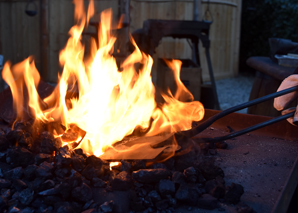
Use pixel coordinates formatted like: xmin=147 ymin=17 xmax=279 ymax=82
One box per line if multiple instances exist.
xmin=177 ymin=110 xmax=298 ymax=212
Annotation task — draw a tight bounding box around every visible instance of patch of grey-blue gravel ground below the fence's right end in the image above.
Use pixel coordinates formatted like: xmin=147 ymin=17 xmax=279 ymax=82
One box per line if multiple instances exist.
xmin=216 ymin=74 xmax=254 ymax=113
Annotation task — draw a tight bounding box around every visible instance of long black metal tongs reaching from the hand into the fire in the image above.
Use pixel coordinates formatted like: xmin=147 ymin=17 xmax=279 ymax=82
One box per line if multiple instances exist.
xmin=181 ymin=85 xmax=298 ymax=143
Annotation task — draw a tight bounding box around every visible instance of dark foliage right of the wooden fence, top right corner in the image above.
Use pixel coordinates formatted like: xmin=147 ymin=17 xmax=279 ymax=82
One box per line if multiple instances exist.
xmin=240 ymin=0 xmax=298 ymax=69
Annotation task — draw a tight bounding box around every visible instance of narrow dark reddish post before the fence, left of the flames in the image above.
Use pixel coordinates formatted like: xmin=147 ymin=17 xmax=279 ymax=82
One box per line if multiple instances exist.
xmin=40 ymin=0 xmax=49 ymax=81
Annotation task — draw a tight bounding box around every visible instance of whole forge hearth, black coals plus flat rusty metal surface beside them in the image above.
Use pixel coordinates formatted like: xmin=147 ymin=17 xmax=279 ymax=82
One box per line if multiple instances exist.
xmin=0 ymin=110 xmax=298 ymax=212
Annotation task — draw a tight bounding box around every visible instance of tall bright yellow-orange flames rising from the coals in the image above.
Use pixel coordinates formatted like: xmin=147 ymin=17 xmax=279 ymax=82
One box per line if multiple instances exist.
xmin=2 ymin=0 xmax=204 ymax=156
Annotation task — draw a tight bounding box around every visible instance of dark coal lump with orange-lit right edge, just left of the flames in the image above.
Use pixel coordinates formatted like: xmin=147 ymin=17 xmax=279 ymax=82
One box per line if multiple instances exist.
xmin=37 ymin=131 xmax=62 ymax=154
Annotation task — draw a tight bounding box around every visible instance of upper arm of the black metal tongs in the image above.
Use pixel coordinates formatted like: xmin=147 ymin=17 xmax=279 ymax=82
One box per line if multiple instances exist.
xmin=183 ymin=86 xmax=298 ymax=137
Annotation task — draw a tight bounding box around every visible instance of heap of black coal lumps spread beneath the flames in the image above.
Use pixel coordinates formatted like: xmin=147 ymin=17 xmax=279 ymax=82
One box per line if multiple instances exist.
xmin=0 ymin=123 xmax=254 ymax=213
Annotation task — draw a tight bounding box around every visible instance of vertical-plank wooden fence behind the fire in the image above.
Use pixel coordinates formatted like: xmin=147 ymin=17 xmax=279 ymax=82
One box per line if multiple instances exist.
xmin=0 ymin=0 xmax=241 ymax=82
